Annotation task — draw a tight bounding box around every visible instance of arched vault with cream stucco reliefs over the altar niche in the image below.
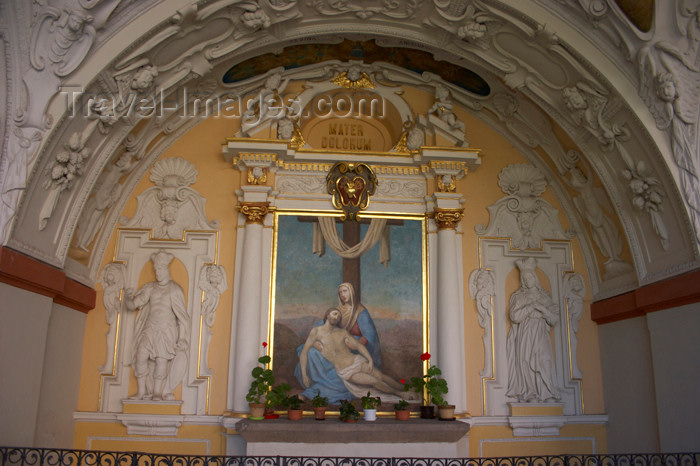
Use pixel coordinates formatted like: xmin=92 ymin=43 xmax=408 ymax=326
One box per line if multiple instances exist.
xmin=0 ymin=0 xmax=700 ymax=298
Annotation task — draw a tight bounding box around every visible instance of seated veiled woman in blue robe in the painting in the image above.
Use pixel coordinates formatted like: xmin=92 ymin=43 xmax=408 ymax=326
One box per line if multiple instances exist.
xmin=294 ymin=283 xmax=382 ymax=403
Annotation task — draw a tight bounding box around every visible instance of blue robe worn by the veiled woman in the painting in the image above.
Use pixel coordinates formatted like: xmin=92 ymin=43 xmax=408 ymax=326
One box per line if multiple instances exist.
xmin=294 ymin=308 xmax=382 ymax=404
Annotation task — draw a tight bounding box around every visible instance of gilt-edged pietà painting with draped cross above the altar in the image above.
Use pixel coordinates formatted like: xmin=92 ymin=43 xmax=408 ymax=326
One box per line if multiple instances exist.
xmin=272 ymin=213 xmax=427 ymax=403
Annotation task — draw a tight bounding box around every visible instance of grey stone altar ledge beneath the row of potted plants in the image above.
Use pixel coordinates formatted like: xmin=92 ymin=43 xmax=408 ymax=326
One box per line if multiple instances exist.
xmin=236 ymin=418 xmax=469 ymax=444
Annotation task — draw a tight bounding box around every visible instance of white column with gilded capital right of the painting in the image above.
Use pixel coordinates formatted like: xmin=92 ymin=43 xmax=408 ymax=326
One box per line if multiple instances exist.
xmin=435 ymin=208 xmax=466 ymax=413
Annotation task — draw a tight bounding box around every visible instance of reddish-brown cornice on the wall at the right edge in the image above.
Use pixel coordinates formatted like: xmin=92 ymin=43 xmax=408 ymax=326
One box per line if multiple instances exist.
xmin=591 ymin=270 xmax=700 ymax=324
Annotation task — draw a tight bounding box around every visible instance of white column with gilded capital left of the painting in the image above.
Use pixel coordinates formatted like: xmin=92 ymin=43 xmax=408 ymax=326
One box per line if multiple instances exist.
xmin=232 ymin=203 xmax=268 ymax=412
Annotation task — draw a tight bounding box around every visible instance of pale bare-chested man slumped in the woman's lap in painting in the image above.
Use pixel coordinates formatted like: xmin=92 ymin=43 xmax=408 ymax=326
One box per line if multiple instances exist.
xmin=299 ymin=308 xmax=404 ymax=397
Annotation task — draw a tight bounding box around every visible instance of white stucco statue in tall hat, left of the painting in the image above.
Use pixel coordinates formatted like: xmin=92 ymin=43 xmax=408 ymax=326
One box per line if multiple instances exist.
xmin=124 ymin=250 xmax=190 ymax=401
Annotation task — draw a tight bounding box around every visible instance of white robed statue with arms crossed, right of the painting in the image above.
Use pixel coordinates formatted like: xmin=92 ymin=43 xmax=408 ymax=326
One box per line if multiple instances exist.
xmin=506 ymin=257 xmax=560 ymax=403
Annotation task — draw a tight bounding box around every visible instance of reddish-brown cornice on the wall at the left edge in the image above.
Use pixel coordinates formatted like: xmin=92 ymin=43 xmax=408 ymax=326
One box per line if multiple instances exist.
xmin=0 ymin=246 xmax=96 ymax=313
